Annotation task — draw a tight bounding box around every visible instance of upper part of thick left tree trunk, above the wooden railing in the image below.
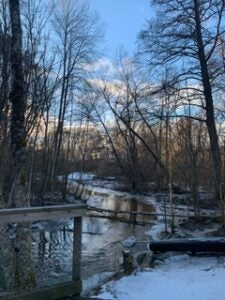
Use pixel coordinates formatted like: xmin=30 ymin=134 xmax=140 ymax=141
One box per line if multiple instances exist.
xmin=9 ymin=0 xmax=27 ymax=207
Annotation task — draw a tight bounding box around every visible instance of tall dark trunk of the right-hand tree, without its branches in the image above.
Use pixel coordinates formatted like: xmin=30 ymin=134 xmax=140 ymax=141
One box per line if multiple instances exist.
xmin=194 ymin=0 xmax=222 ymax=199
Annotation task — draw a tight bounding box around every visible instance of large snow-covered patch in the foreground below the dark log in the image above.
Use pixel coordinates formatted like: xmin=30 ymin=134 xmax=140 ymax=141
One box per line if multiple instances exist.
xmin=92 ymin=254 xmax=225 ymax=300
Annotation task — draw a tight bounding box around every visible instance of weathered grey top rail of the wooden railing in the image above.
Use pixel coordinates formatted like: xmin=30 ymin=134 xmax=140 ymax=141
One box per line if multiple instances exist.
xmin=0 ymin=204 xmax=87 ymax=223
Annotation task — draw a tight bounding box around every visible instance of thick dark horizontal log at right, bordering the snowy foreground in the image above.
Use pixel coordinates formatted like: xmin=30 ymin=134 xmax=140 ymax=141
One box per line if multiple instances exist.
xmin=149 ymin=238 xmax=225 ymax=253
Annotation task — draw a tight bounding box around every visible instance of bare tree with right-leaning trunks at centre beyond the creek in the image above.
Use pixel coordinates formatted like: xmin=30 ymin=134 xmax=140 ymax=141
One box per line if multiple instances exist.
xmin=87 ymin=57 xmax=168 ymax=189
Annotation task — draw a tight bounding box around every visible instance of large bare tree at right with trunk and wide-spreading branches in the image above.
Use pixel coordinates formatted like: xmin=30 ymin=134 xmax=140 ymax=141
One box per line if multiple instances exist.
xmin=139 ymin=0 xmax=225 ymax=197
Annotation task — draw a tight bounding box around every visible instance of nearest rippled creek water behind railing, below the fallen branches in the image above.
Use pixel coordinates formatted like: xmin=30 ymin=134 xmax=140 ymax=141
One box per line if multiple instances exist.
xmin=32 ymin=217 xmax=149 ymax=286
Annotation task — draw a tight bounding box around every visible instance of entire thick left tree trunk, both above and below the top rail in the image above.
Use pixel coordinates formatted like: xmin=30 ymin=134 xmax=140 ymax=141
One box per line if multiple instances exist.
xmin=9 ymin=0 xmax=35 ymax=290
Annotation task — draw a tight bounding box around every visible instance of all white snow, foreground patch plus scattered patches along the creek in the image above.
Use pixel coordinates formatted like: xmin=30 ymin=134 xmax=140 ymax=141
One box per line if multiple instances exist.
xmin=64 ymin=173 xmax=225 ymax=300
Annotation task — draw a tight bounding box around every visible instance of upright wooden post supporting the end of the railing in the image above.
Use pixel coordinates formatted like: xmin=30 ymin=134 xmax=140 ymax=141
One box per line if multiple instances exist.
xmin=72 ymin=217 xmax=82 ymax=281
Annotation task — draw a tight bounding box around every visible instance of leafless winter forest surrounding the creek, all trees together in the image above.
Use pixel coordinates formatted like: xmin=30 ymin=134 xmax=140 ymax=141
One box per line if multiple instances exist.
xmin=0 ymin=0 xmax=225 ymax=296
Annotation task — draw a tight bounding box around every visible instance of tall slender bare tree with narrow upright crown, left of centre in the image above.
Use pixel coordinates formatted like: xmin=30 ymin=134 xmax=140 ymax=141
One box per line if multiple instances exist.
xmin=46 ymin=0 xmax=100 ymax=188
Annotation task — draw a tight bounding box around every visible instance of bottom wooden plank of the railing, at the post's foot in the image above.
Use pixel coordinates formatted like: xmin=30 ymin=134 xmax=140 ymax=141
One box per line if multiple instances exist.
xmin=0 ymin=280 xmax=82 ymax=300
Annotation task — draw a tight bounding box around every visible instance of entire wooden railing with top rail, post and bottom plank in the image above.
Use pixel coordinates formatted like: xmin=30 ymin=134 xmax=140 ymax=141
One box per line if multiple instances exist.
xmin=0 ymin=205 xmax=87 ymax=300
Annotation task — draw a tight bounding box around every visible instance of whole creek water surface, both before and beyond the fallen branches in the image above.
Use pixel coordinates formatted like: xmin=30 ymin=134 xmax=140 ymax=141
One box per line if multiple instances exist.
xmin=32 ymin=185 xmax=155 ymax=291
